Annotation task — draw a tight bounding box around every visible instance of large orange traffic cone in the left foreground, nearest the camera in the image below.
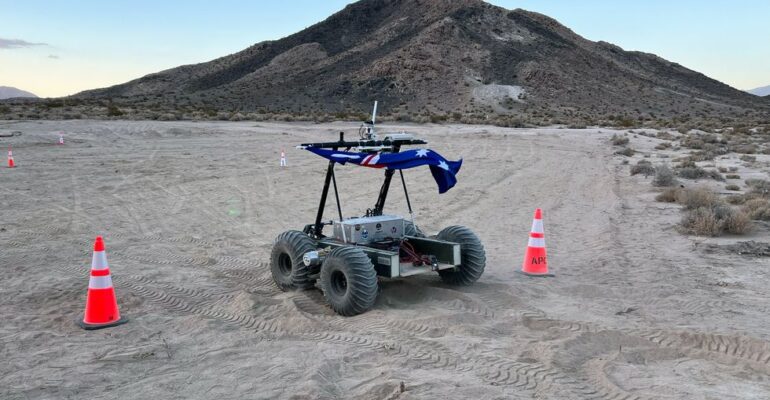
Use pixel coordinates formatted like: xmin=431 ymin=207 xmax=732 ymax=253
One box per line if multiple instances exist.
xmin=78 ymin=236 xmax=126 ymax=330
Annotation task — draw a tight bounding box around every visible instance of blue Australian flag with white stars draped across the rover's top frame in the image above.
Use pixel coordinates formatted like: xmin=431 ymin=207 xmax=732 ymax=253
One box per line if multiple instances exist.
xmin=305 ymin=147 xmax=463 ymax=193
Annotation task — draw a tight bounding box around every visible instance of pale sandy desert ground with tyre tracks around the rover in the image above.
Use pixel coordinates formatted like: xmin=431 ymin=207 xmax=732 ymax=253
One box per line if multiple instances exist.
xmin=0 ymin=121 xmax=770 ymax=399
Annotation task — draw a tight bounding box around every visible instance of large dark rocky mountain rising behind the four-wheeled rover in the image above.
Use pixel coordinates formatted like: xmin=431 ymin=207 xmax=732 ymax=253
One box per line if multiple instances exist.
xmin=74 ymin=0 xmax=768 ymax=120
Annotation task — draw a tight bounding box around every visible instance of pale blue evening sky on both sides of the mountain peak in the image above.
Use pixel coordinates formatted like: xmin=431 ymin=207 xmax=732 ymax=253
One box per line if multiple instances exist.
xmin=0 ymin=0 xmax=770 ymax=97
